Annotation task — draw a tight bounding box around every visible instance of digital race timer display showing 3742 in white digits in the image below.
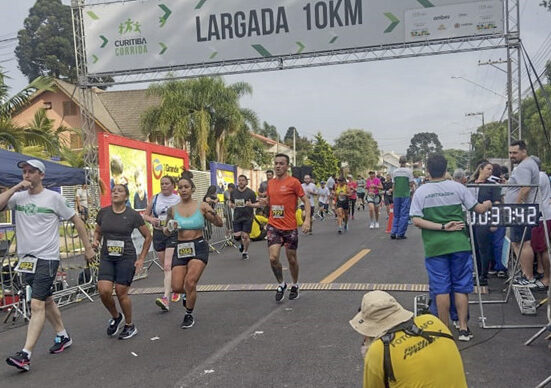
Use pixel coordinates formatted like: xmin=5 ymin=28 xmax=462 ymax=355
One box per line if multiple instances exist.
xmin=471 ymin=203 xmax=539 ymax=226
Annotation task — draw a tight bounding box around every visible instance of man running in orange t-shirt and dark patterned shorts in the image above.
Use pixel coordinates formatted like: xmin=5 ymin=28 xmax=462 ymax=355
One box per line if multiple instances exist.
xmin=260 ymin=154 xmax=311 ymax=302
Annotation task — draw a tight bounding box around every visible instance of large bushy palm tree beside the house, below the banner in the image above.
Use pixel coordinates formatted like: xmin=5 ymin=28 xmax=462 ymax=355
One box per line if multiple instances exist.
xmin=142 ymin=77 xmax=258 ymax=170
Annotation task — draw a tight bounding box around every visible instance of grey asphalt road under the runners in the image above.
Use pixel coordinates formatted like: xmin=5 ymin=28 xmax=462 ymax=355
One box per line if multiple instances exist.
xmin=0 ymin=212 xmax=551 ymax=388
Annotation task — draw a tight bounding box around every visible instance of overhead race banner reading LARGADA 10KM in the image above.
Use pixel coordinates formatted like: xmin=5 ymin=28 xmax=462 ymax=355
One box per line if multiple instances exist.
xmin=83 ymin=0 xmax=504 ymax=74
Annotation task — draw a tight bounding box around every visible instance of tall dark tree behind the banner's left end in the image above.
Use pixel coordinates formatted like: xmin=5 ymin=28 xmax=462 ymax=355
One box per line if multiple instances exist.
xmin=15 ymin=0 xmax=113 ymax=88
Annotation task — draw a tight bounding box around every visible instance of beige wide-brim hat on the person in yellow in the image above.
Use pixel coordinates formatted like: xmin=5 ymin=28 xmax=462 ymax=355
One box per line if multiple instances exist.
xmin=350 ymin=291 xmax=413 ymax=338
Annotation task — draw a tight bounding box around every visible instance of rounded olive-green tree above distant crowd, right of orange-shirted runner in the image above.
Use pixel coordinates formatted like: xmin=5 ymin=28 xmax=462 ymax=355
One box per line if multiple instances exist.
xmin=333 ymin=129 xmax=380 ymax=175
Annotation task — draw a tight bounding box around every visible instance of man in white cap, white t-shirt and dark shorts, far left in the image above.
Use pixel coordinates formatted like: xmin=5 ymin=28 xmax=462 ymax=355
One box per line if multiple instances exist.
xmin=0 ymin=160 xmax=95 ymax=371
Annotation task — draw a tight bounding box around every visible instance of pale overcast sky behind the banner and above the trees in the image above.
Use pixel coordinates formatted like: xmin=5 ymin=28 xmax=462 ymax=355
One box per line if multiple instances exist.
xmin=0 ymin=0 xmax=551 ymax=153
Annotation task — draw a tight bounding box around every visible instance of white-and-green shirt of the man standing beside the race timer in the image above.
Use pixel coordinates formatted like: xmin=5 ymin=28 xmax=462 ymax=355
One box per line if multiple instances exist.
xmin=409 ymin=180 xmax=478 ymax=257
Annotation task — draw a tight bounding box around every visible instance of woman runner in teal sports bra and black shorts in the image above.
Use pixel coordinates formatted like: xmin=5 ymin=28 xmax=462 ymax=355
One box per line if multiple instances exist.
xmin=163 ymin=171 xmax=224 ymax=329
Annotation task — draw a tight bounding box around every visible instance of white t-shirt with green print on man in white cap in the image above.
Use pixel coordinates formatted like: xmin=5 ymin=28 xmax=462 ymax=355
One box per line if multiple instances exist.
xmin=8 ymin=189 xmax=75 ymax=260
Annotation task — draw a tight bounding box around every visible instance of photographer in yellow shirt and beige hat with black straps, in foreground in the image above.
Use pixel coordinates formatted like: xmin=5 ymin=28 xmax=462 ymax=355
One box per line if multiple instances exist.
xmin=350 ymin=291 xmax=467 ymax=388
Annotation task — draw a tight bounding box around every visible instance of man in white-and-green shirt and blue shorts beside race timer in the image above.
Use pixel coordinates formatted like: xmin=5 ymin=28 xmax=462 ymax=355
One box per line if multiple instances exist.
xmin=410 ymin=154 xmax=492 ymax=341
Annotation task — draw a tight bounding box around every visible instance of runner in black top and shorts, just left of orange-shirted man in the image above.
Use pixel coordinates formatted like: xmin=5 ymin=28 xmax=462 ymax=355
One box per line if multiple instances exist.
xmin=230 ymin=175 xmax=256 ymax=260
